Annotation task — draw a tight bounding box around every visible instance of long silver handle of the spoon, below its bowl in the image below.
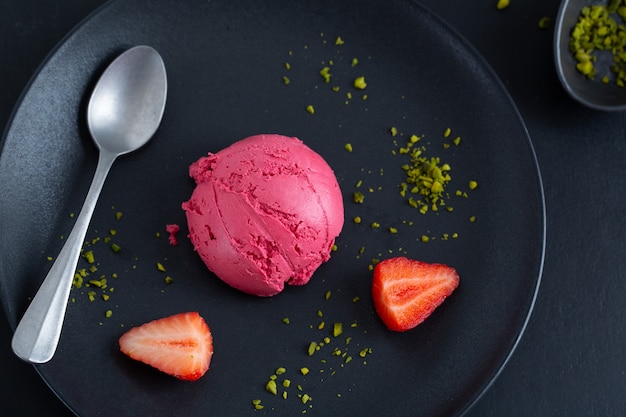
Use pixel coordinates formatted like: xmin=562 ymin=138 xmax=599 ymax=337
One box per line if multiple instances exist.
xmin=11 ymin=150 xmax=117 ymax=363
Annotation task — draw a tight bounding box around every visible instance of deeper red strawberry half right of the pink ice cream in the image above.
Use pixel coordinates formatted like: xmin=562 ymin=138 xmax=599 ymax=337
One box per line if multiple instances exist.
xmin=372 ymin=257 xmax=459 ymax=332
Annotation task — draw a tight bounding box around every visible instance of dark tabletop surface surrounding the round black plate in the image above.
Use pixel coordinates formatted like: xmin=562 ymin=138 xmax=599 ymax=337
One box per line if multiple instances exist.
xmin=0 ymin=0 xmax=626 ymax=417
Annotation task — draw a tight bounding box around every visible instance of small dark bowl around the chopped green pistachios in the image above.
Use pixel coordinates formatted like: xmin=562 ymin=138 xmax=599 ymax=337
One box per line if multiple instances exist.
xmin=554 ymin=0 xmax=626 ymax=111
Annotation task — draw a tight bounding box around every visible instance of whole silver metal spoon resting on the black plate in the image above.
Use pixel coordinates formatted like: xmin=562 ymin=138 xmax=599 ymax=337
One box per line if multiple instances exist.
xmin=11 ymin=46 xmax=167 ymax=363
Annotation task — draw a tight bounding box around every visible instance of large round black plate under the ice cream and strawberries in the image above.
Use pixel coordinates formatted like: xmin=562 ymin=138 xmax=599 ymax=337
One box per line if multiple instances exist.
xmin=0 ymin=0 xmax=545 ymax=417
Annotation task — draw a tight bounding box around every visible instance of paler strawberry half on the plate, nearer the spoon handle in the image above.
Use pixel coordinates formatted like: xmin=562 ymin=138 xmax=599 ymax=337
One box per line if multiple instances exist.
xmin=119 ymin=312 xmax=213 ymax=381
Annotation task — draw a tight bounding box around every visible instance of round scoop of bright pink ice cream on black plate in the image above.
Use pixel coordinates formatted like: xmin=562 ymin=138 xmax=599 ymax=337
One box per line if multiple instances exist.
xmin=182 ymin=135 xmax=344 ymax=296
